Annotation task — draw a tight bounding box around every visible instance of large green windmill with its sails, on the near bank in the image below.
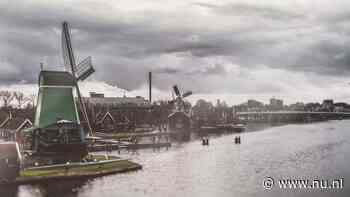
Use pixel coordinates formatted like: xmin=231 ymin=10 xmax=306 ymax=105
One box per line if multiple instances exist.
xmin=27 ymin=22 xmax=94 ymax=162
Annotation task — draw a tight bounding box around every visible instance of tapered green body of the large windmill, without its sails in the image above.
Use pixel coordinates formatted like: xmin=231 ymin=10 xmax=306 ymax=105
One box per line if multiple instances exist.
xmin=26 ymin=70 xmax=87 ymax=161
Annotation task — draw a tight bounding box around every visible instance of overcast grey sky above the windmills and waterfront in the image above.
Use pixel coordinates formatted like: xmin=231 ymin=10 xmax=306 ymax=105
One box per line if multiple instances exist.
xmin=0 ymin=0 xmax=350 ymax=104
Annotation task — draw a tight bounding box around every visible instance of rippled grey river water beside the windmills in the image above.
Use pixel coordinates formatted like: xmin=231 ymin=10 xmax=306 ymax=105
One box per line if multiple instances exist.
xmin=1 ymin=120 xmax=350 ymax=197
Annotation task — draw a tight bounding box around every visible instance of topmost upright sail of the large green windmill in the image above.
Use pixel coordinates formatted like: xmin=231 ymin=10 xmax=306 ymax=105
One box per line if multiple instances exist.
xmin=62 ymin=22 xmax=76 ymax=74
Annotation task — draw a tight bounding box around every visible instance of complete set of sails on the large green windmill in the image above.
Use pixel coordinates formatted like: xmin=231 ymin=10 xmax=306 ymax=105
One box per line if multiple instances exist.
xmin=62 ymin=22 xmax=95 ymax=135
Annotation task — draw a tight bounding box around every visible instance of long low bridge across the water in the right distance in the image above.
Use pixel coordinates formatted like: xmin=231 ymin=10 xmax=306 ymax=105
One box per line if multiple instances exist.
xmin=236 ymin=111 xmax=350 ymax=122
